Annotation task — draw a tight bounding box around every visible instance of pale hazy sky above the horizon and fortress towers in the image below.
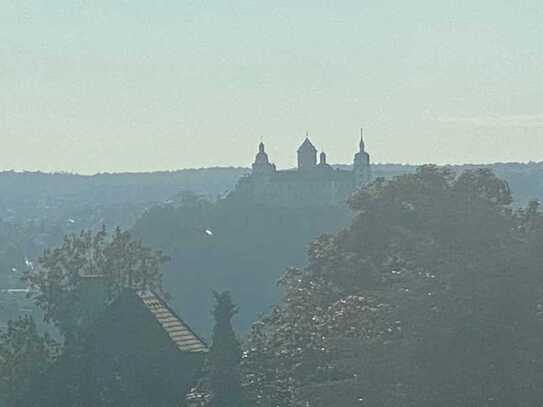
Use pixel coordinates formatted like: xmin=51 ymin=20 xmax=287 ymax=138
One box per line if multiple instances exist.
xmin=0 ymin=0 xmax=543 ymax=173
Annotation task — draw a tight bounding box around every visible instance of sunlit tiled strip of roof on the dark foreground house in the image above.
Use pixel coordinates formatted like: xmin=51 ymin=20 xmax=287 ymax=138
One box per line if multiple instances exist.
xmin=136 ymin=291 xmax=208 ymax=352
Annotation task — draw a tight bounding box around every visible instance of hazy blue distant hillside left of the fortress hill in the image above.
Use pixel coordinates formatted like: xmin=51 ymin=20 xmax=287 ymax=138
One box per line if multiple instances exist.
xmin=0 ymin=168 xmax=245 ymax=290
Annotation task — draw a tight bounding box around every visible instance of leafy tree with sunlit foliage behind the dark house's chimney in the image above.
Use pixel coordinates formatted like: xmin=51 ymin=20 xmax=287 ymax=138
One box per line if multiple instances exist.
xmin=24 ymin=227 xmax=167 ymax=339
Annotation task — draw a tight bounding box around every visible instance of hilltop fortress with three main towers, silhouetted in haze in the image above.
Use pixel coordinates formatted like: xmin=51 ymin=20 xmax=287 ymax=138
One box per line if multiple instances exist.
xmin=232 ymin=132 xmax=371 ymax=207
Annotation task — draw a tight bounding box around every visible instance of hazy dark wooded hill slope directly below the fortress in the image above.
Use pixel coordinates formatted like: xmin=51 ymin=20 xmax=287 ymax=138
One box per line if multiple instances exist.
xmin=133 ymin=196 xmax=351 ymax=332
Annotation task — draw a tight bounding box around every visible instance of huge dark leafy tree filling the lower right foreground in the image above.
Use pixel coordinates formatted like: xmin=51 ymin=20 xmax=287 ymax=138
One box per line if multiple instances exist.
xmin=243 ymin=166 xmax=543 ymax=407
